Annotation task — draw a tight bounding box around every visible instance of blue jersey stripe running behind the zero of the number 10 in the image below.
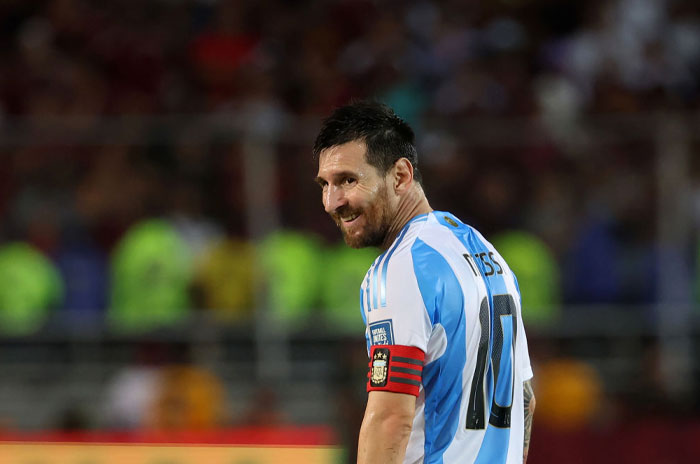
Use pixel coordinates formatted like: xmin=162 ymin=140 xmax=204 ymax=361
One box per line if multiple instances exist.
xmin=435 ymin=212 xmax=513 ymax=464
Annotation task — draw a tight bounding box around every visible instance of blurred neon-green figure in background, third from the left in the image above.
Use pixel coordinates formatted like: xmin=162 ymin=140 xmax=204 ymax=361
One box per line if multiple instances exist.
xmin=258 ymin=230 xmax=323 ymax=327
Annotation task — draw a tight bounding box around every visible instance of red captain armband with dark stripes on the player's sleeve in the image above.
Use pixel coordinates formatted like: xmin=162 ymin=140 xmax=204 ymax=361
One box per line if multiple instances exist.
xmin=367 ymin=345 xmax=425 ymax=396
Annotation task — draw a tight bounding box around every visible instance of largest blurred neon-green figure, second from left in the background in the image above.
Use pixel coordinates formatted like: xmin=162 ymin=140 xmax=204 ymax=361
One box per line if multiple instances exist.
xmin=108 ymin=219 xmax=191 ymax=331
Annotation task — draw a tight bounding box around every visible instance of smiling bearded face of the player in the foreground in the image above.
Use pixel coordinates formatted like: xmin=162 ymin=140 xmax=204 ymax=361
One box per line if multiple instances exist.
xmin=316 ymin=141 xmax=393 ymax=248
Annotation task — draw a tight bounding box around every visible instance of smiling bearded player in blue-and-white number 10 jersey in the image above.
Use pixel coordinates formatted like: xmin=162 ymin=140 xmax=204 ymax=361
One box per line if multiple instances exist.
xmin=314 ymin=102 xmax=535 ymax=464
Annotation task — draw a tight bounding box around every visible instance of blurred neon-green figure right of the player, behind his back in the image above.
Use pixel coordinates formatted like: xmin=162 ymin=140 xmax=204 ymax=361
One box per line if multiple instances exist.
xmin=492 ymin=230 xmax=561 ymax=326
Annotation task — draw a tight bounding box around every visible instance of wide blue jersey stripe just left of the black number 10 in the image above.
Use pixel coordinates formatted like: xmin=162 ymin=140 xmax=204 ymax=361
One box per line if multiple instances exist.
xmin=411 ymin=239 xmax=467 ymax=464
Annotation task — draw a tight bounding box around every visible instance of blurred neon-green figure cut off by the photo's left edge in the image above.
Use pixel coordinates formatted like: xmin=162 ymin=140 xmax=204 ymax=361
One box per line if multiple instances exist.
xmin=0 ymin=242 xmax=64 ymax=336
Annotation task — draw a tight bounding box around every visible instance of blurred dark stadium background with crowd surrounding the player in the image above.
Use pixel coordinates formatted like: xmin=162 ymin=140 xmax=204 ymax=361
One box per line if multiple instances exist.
xmin=0 ymin=0 xmax=700 ymax=464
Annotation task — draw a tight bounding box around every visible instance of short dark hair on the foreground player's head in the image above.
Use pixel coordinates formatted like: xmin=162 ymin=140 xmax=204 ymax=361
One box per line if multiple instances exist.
xmin=314 ymin=100 xmax=421 ymax=184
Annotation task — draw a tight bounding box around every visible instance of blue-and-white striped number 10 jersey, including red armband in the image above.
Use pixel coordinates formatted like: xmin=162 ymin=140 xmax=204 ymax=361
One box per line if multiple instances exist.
xmin=360 ymin=211 xmax=532 ymax=464
